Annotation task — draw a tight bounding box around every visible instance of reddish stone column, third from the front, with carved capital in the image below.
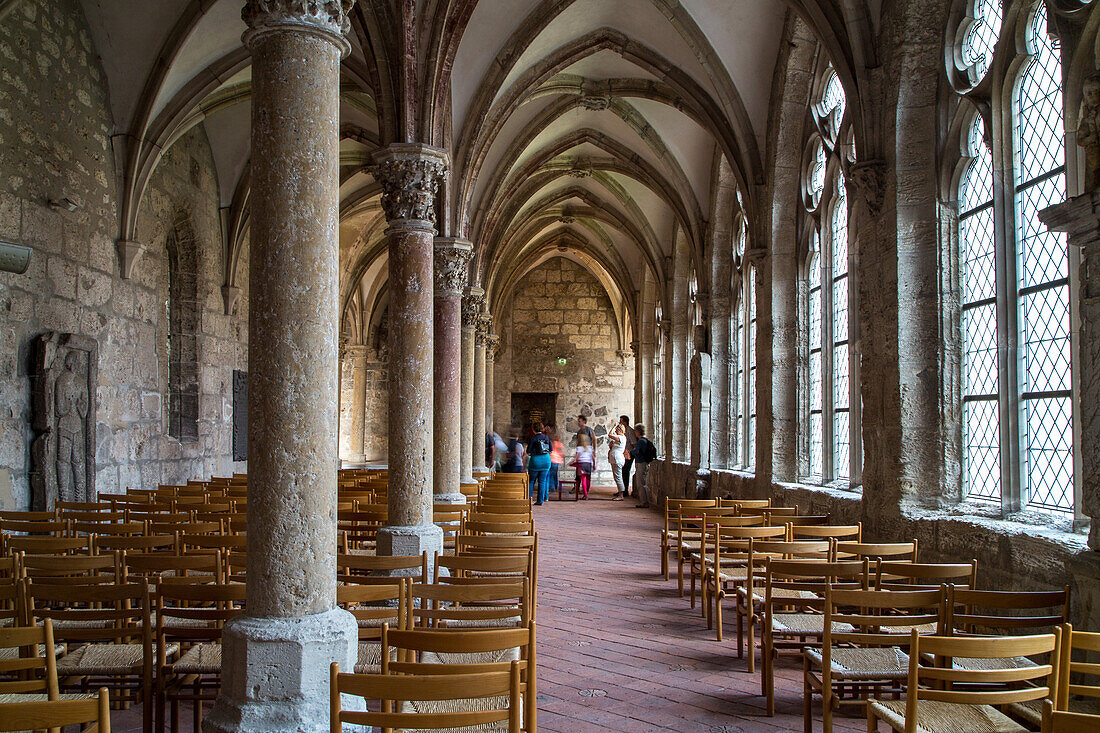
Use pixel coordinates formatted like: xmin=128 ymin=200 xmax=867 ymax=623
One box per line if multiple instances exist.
xmin=433 ymin=237 xmax=473 ymax=504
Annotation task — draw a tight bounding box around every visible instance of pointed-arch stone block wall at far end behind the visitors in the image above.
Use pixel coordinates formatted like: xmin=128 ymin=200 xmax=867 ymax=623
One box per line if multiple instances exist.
xmin=492 ymin=258 xmax=634 ymax=485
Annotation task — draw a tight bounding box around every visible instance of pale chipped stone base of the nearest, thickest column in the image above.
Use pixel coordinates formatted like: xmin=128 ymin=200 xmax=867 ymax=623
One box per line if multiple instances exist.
xmin=202 ymin=609 xmax=363 ymax=733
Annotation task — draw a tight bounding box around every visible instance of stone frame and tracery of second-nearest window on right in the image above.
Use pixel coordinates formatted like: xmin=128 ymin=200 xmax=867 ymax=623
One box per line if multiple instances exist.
xmin=799 ymin=55 xmax=862 ymax=491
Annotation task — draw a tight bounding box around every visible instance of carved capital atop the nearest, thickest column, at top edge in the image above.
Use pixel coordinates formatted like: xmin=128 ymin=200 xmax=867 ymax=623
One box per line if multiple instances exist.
xmin=241 ymin=0 xmax=355 ymax=56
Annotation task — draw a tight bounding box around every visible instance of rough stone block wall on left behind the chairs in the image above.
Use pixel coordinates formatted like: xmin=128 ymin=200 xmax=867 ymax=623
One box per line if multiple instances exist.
xmin=0 ymin=0 xmax=248 ymax=508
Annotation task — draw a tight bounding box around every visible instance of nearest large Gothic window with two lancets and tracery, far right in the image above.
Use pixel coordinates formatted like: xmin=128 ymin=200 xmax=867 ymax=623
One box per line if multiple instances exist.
xmin=949 ymin=0 xmax=1079 ymax=516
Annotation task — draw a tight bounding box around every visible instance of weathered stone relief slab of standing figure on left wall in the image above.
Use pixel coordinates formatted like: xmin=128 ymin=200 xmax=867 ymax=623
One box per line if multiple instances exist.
xmin=31 ymin=331 xmax=99 ymax=510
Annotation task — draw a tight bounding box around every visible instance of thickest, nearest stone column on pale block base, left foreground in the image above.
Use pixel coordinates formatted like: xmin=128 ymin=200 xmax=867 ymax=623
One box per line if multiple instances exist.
xmin=205 ymin=0 xmax=359 ymax=732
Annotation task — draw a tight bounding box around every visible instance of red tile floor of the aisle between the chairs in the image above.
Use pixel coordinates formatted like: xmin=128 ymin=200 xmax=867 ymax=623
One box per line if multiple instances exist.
xmin=112 ymin=489 xmax=867 ymax=733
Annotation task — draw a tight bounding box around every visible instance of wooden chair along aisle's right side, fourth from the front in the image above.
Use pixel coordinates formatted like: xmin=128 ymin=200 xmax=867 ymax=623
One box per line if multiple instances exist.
xmin=735 ymin=537 xmax=833 ymax=674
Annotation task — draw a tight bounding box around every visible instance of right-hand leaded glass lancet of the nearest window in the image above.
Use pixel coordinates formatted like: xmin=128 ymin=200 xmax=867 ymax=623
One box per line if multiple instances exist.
xmin=1013 ymin=2 xmax=1074 ymax=511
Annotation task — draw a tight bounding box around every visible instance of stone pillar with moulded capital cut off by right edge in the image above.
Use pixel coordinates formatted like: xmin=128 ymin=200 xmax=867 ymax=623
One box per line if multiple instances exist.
xmin=1038 ymin=190 xmax=1100 ymax=541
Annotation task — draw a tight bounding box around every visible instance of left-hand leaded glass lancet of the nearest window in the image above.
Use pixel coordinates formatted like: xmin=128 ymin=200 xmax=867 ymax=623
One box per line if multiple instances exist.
xmin=959 ymin=116 xmax=1001 ymax=501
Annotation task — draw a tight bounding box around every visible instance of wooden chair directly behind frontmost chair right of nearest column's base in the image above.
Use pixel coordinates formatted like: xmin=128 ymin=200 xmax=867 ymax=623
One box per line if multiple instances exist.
xmin=382 ymin=622 xmax=538 ymax=733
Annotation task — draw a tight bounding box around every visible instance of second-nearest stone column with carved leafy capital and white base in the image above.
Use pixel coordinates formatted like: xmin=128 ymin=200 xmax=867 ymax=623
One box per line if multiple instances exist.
xmin=373 ymin=143 xmax=447 ymax=558
